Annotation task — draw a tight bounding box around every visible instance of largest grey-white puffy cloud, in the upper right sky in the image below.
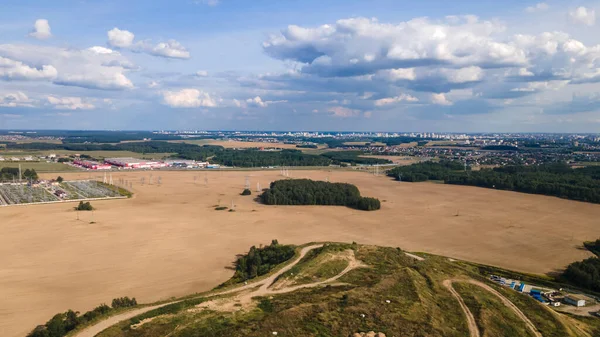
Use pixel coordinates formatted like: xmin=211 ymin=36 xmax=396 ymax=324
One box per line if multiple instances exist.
xmin=263 ymin=16 xmax=527 ymax=76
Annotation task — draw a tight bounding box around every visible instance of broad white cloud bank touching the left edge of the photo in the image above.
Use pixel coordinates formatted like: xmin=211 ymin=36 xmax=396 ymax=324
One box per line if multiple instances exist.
xmin=0 ymin=44 xmax=134 ymax=90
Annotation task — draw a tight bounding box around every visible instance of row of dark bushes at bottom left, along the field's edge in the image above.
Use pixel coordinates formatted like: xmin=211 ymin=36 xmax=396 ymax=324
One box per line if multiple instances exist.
xmin=27 ymin=297 xmax=137 ymax=337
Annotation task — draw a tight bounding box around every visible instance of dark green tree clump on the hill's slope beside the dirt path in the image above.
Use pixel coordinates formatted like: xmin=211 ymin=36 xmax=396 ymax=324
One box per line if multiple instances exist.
xmin=233 ymin=240 xmax=295 ymax=281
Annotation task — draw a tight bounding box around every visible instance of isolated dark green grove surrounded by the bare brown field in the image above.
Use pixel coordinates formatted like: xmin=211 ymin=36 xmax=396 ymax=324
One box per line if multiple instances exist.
xmin=260 ymin=179 xmax=381 ymax=211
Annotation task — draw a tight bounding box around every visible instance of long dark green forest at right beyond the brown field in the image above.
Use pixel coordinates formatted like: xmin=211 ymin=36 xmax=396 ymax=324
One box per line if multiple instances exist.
xmin=388 ymin=162 xmax=600 ymax=203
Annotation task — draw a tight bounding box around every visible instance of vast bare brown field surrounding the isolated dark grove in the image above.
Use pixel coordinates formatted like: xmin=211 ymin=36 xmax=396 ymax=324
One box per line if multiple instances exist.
xmin=0 ymin=171 xmax=600 ymax=337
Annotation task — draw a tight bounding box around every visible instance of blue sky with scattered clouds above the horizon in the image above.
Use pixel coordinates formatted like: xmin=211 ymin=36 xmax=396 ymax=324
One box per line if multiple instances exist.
xmin=0 ymin=0 xmax=600 ymax=133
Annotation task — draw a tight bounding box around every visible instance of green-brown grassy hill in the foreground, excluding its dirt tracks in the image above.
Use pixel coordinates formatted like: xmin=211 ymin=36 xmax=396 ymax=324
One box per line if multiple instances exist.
xmin=90 ymin=244 xmax=600 ymax=337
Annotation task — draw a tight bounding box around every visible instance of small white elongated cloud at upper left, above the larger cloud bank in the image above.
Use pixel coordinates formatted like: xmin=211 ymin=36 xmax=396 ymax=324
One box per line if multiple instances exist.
xmin=107 ymin=27 xmax=190 ymax=59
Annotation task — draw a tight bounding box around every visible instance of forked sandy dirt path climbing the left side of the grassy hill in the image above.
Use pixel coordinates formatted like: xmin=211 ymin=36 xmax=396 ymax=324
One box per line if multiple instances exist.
xmin=70 ymin=244 xmax=326 ymax=337
